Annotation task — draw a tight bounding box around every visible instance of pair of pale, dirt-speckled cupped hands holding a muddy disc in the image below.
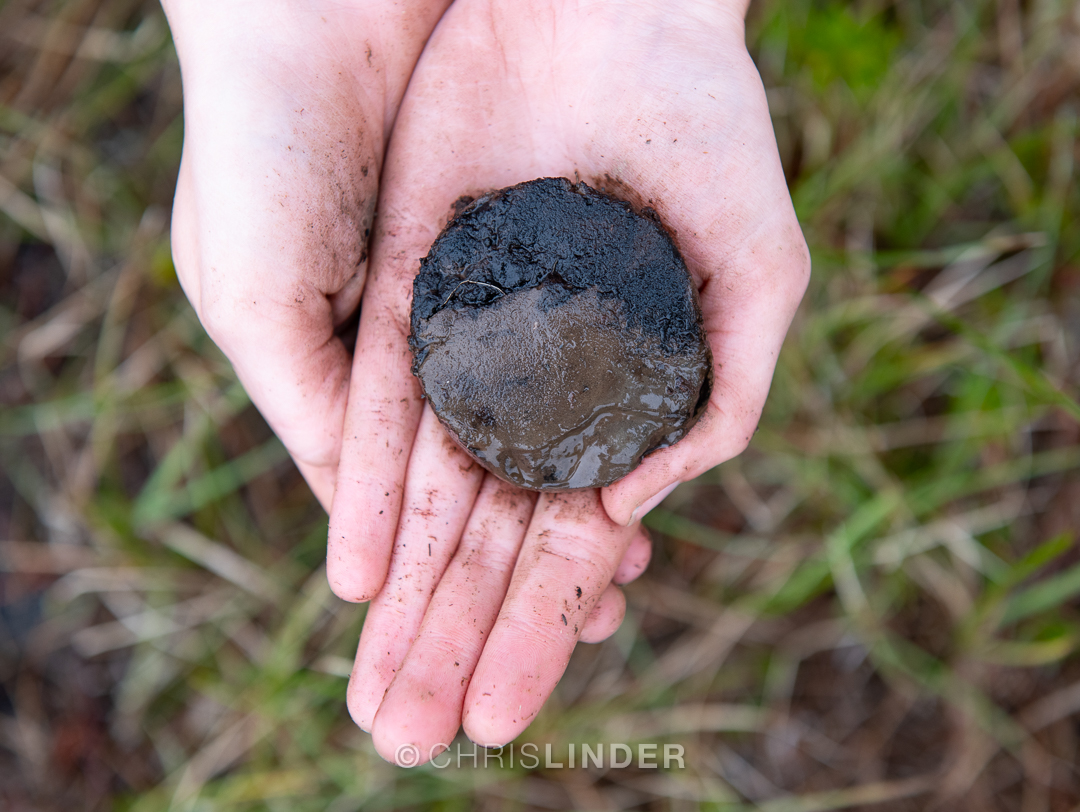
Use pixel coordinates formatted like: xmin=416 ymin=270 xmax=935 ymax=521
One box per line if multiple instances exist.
xmin=165 ymin=0 xmax=809 ymax=760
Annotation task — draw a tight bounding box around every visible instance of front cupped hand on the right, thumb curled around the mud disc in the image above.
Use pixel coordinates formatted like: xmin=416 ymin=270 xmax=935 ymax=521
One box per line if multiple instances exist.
xmin=327 ymin=0 xmax=809 ymax=759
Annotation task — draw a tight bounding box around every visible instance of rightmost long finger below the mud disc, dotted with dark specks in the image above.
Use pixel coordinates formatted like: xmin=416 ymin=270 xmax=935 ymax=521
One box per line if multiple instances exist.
xmin=462 ymin=490 xmax=634 ymax=746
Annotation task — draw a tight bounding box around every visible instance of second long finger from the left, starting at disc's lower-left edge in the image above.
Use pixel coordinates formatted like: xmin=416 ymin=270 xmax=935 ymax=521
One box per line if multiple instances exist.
xmin=348 ymin=408 xmax=484 ymax=730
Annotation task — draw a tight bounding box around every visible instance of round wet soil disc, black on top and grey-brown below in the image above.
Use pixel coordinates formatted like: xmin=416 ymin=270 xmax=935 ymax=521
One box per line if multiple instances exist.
xmin=409 ymin=178 xmax=712 ymax=490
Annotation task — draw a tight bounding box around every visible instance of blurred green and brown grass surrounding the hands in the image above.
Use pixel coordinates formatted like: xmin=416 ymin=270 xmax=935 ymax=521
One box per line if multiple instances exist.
xmin=0 ymin=0 xmax=1080 ymax=812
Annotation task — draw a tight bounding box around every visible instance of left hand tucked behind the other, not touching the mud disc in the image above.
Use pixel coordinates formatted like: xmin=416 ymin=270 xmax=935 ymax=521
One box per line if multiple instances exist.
xmin=165 ymin=0 xmax=449 ymax=509
